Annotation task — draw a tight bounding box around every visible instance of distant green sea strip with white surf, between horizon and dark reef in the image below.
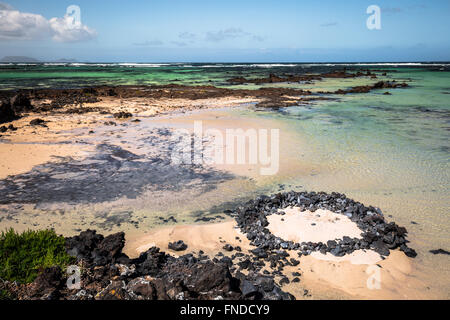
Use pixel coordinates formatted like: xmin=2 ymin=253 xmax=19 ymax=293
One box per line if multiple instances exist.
xmin=0 ymin=63 xmax=450 ymax=90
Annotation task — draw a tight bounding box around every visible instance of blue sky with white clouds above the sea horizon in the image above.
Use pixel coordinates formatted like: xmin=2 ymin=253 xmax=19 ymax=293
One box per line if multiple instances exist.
xmin=0 ymin=0 xmax=450 ymax=62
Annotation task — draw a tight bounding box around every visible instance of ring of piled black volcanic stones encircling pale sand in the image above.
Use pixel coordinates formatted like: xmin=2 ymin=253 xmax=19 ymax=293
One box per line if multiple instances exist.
xmin=231 ymin=190 xmax=417 ymax=260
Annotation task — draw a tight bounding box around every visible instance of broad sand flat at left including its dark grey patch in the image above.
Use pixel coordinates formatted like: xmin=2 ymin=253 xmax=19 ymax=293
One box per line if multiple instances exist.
xmin=0 ymin=99 xmax=312 ymax=235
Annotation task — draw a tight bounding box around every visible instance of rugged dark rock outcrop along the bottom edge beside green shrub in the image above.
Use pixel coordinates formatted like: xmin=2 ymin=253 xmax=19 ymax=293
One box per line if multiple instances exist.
xmin=2 ymin=230 xmax=294 ymax=300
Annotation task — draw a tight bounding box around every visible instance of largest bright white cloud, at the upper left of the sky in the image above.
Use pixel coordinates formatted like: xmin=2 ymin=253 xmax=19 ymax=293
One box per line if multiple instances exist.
xmin=0 ymin=2 xmax=97 ymax=42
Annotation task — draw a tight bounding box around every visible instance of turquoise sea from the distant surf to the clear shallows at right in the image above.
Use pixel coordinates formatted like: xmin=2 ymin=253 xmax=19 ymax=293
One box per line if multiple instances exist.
xmin=0 ymin=63 xmax=450 ymax=298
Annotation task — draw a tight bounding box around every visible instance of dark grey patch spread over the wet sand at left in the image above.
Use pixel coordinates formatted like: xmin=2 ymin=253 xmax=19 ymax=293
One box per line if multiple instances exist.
xmin=0 ymin=144 xmax=234 ymax=204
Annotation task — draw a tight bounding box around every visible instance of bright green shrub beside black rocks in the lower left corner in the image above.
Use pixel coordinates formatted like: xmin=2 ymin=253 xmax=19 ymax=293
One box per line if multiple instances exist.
xmin=0 ymin=229 xmax=74 ymax=283
